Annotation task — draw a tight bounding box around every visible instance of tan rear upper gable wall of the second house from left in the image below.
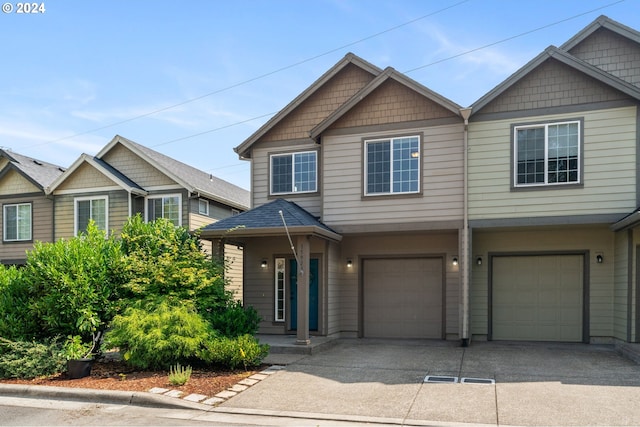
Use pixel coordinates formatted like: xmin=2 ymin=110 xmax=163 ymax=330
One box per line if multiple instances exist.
xmin=101 ymin=144 xmax=176 ymax=188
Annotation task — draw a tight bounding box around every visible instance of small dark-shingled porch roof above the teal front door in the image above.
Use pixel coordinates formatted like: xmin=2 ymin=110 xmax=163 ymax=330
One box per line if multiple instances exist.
xmin=201 ymin=199 xmax=342 ymax=241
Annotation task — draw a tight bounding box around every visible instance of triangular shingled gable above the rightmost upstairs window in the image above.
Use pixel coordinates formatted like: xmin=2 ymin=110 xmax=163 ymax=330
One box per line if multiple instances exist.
xmin=482 ymin=59 xmax=629 ymax=114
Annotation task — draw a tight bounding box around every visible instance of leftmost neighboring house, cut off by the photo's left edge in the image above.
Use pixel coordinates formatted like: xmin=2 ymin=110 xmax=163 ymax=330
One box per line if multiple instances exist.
xmin=0 ymin=150 xmax=64 ymax=265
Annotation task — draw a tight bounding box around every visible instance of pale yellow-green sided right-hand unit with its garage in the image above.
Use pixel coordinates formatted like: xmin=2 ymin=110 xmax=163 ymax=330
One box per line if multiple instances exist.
xmin=468 ymin=17 xmax=640 ymax=343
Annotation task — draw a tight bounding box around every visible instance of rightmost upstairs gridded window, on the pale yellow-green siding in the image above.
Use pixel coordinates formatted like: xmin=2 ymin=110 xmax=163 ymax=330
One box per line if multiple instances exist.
xmin=514 ymin=121 xmax=580 ymax=187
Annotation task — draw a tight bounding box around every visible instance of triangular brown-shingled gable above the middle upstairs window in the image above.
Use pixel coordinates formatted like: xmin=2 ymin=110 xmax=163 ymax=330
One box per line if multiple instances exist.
xmin=330 ymin=79 xmax=458 ymax=129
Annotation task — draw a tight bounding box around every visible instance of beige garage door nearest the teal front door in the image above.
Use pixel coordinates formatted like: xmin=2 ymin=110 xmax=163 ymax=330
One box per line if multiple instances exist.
xmin=363 ymin=258 xmax=443 ymax=338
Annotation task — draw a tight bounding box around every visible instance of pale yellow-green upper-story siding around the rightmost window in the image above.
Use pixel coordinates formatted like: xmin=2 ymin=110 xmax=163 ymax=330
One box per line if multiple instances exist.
xmin=469 ymin=107 xmax=637 ymax=220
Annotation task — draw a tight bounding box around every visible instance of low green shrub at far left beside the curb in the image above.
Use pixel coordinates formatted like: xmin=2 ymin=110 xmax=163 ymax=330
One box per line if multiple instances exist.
xmin=0 ymin=337 xmax=66 ymax=378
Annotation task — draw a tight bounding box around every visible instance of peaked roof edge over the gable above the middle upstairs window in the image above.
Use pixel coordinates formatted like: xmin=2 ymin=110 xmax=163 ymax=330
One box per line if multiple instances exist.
xmin=310 ymin=67 xmax=462 ymax=139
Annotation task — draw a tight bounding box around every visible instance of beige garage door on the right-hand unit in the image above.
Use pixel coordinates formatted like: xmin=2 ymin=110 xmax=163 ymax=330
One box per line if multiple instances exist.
xmin=492 ymin=255 xmax=584 ymax=342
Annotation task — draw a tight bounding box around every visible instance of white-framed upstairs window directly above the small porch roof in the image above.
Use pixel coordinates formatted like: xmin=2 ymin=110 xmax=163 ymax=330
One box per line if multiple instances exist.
xmin=271 ymin=151 xmax=318 ymax=194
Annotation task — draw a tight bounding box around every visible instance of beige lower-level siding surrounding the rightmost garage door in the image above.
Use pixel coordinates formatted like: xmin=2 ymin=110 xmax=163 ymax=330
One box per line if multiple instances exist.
xmin=470 ymin=226 xmax=614 ymax=341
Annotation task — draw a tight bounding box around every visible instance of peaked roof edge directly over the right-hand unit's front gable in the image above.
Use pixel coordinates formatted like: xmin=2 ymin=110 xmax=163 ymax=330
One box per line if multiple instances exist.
xmin=471 ymin=46 xmax=640 ymax=115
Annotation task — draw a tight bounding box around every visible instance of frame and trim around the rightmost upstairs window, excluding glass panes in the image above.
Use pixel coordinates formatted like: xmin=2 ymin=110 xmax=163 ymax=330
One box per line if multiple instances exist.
xmin=510 ymin=117 xmax=584 ymax=191
